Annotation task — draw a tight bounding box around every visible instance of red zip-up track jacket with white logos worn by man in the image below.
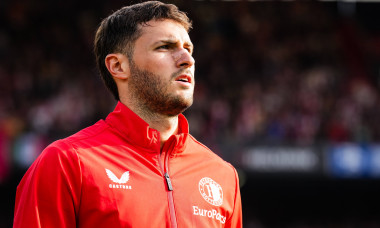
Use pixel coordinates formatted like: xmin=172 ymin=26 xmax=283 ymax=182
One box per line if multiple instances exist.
xmin=14 ymin=103 xmax=242 ymax=228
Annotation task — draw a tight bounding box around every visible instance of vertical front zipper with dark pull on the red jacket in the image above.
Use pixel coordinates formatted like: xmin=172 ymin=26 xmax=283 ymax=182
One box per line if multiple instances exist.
xmin=159 ymin=145 xmax=178 ymax=228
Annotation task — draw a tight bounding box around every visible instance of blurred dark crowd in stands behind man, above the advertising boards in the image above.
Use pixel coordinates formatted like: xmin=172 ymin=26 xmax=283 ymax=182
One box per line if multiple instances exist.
xmin=0 ymin=0 xmax=380 ymax=227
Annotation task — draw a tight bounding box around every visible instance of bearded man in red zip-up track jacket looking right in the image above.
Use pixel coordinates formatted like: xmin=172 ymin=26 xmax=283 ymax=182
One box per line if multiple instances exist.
xmin=14 ymin=2 xmax=242 ymax=228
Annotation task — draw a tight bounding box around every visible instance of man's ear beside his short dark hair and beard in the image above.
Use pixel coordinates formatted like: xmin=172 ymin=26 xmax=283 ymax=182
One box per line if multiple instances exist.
xmin=105 ymin=53 xmax=130 ymax=80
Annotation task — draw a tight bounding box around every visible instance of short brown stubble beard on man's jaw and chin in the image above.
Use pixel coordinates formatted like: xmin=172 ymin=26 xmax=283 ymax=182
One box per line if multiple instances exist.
xmin=129 ymin=61 xmax=193 ymax=117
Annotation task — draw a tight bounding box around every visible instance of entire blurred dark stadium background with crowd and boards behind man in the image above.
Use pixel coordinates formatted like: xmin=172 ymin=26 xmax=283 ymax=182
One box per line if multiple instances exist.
xmin=0 ymin=0 xmax=380 ymax=228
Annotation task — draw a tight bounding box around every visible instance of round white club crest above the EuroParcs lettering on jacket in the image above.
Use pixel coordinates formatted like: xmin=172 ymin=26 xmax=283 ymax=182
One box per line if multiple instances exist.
xmin=199 ymin=177 xmax=223 ymax=206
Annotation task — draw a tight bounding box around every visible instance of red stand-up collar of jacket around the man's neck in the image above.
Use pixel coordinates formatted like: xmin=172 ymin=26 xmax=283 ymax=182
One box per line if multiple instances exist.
xmin=105 ymin=101 xmax=189 ymax=153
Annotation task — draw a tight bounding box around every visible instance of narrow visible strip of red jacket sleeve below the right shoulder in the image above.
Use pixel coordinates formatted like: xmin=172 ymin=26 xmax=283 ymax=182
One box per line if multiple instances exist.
xmin=225 ymin=168 xmax=243 ymax=228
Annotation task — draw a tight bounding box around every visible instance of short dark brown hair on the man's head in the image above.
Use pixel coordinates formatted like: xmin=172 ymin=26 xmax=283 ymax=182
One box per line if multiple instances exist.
xmin=94 ymin=1 xmax=191 ymax=100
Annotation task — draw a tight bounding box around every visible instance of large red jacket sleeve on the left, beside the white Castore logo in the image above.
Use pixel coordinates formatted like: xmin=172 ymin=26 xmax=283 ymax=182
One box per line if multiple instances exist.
xmin=13 ymin=141 xmax=81 ymax=228
